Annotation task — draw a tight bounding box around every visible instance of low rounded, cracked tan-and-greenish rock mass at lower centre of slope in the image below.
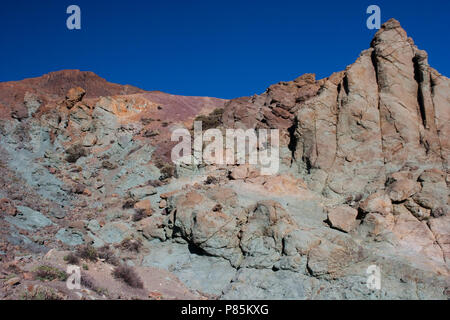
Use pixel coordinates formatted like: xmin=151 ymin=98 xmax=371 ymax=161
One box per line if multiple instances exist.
xmin=163 ymin=187 xmax=297 ymax=268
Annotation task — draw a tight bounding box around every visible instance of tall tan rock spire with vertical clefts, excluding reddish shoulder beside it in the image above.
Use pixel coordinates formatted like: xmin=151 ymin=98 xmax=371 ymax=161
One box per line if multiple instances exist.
xmin=290 ymin=20 xmax=448 ymax=201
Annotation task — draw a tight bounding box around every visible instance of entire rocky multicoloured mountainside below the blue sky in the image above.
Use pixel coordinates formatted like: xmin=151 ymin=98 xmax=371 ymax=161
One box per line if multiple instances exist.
xmin=0 ymin=19 xmax=450 ymax=299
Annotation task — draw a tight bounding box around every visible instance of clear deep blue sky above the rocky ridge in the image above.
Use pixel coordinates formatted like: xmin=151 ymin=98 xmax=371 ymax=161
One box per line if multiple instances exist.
xmin=0 ymin=0 xmax=450 ymax=98
